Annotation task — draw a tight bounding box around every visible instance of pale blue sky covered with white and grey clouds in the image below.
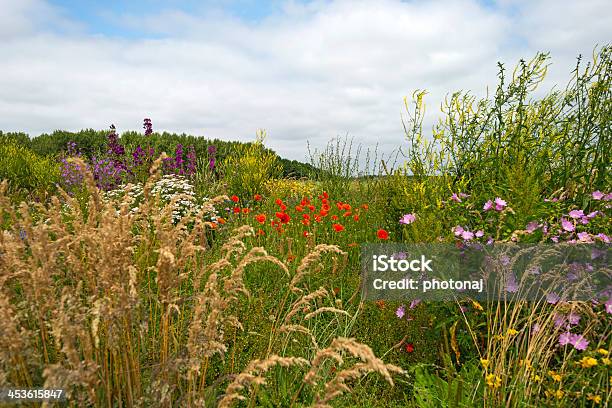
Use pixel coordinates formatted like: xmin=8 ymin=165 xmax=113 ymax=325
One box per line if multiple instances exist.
xmin=0 ymin=0 xmax=612 ymax=160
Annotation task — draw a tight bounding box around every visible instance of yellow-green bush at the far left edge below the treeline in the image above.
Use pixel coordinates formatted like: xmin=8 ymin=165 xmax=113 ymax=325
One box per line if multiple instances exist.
xmin=0 ymin=140 xmax=60 ymax=198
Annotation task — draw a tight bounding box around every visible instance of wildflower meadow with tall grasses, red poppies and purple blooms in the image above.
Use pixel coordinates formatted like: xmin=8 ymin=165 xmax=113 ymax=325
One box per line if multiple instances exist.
xmin=0 ymin=46 xmax=612 ymax=407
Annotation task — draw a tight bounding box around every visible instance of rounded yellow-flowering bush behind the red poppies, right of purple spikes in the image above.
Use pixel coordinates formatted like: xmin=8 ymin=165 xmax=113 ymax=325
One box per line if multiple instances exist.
xmin=220 ymin=130 xmax=281 ymax=197
